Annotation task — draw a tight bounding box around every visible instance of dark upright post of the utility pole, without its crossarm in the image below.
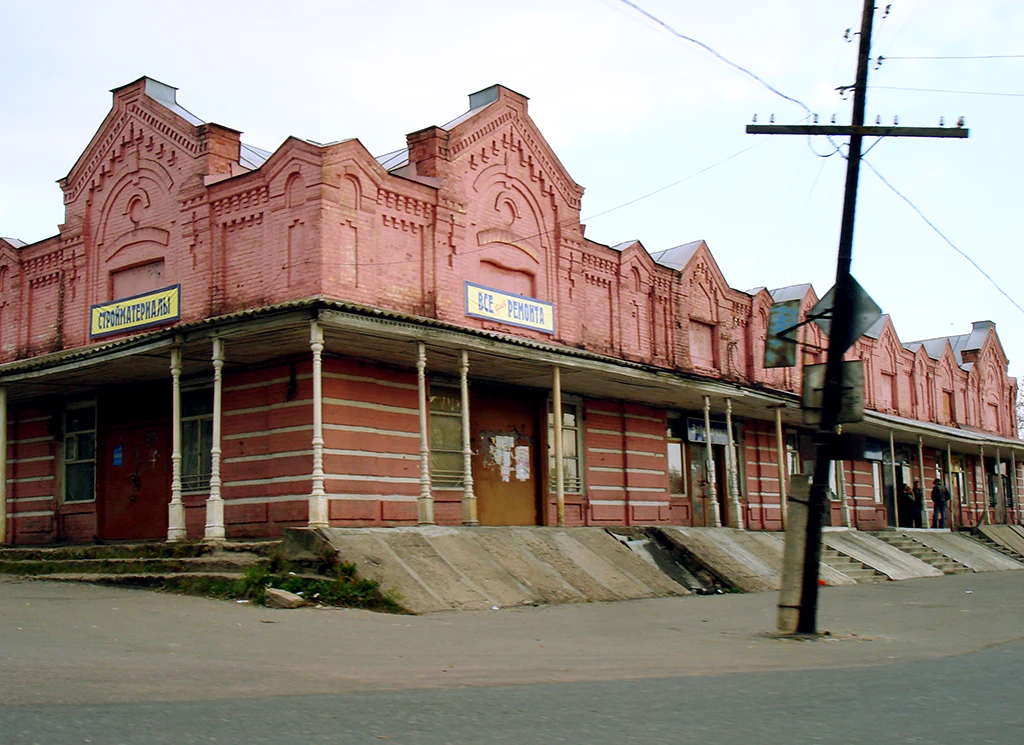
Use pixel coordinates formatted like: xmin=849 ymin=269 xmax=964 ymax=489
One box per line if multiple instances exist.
xmin=797 ymin=0 xmax=874 ymax=633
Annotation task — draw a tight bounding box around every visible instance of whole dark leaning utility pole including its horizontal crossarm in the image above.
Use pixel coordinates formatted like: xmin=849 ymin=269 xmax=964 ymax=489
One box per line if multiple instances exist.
xmin=746 ymin=0 xmax=968 ymax=633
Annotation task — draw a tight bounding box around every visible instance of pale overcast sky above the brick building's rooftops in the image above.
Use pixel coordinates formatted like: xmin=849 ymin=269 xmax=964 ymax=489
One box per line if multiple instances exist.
xmin=0 ymin=0 xmax=1024 ymax=377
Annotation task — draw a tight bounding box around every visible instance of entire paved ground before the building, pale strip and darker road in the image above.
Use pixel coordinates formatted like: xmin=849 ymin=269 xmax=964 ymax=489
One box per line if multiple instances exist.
xmin=0 ymin=572 xmax=1024 ymax=745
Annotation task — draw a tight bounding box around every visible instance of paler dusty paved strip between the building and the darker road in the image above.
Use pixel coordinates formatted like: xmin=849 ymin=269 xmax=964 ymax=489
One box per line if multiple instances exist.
xmin=0 ymin=572 xmax=1024 ymax=705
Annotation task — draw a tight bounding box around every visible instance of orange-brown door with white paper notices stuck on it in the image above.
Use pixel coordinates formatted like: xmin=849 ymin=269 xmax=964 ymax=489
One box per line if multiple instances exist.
xmin=470 ymin=385 xmax=543 ymax=525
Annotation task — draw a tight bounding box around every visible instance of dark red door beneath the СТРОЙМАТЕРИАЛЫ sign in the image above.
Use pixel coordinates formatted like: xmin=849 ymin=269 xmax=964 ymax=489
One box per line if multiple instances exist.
xmin=98 ymin=423 xmax=171 ymax=540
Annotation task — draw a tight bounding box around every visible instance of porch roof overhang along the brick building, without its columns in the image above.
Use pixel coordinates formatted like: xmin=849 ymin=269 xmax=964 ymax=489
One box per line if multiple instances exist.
xmin=0 ymin=296 xmax=1024 ymax=452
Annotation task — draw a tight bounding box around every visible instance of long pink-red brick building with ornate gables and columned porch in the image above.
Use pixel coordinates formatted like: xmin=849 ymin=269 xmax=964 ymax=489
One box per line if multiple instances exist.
xmin=0 ymin=78 xmax=1024 ymax=543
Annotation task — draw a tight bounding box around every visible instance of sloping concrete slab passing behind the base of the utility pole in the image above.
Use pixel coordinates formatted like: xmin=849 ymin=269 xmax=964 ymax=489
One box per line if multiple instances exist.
xmin=656 ymin=527 xmax=857 ymax=593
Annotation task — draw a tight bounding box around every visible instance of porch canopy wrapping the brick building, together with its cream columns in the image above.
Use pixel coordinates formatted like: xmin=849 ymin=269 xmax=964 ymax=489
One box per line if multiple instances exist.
xmin=0 ymin=297 xmax=1024 ymax=540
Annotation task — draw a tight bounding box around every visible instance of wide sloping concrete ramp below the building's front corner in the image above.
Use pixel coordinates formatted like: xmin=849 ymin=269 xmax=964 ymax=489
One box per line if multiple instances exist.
xmin=284 ymin=526 xmax=688 ymax=613
